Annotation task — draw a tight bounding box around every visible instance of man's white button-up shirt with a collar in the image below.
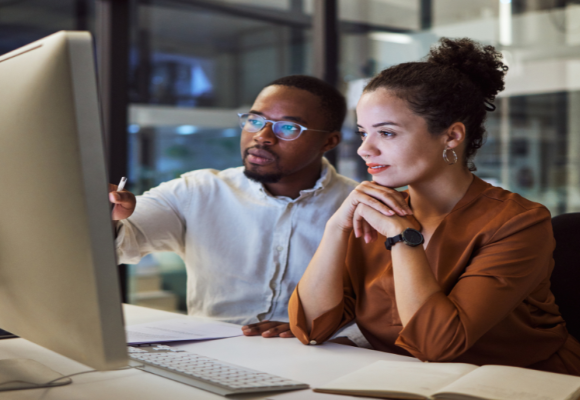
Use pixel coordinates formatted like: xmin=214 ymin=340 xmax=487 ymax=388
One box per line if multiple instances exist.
xmin=116 ymin=159 xmax=370 ymax=346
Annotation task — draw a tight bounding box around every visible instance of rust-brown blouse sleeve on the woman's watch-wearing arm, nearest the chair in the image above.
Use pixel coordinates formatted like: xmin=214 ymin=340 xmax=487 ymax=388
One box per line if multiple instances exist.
xmin=395 ymin=208 xmax=555 ymax=361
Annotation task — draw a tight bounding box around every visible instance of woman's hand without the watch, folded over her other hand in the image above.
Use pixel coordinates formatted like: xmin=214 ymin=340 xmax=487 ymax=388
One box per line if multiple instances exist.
xmin=329 ymin=182 xmax=413 ymax=239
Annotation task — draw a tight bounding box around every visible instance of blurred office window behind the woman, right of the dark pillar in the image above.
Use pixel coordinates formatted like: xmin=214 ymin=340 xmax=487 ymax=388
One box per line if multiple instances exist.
xmin=339 ymin=0 xmax=580 ymax=215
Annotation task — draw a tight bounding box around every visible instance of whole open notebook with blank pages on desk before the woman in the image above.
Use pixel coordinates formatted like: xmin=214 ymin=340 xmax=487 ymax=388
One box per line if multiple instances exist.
xmin=314 ymin=361 xmax=580 ymax=400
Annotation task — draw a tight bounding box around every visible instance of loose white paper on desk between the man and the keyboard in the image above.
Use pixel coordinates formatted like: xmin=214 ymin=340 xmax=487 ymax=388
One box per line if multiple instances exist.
xmin=125 ymin=319 xmax=242 ymax=344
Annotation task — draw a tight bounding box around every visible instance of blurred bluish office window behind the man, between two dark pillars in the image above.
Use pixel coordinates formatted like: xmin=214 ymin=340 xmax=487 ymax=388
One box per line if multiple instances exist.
xmin=128 ymin=1 xmax=312 ymax=312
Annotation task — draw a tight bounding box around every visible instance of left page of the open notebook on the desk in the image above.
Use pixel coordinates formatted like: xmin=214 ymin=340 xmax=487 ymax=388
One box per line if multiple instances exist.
xmin=317 ymin=361 xmax=478 ymax=398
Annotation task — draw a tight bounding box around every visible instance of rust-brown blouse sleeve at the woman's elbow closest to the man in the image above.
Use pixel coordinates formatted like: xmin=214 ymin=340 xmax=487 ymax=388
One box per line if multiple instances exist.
xmin=288 ymin=236 xmax=355 ymax=344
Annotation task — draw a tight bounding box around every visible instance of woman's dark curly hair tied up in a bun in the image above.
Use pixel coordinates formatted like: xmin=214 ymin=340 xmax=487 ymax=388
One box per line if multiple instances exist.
xmin=364 ymin=38 xmax=508 ymax=171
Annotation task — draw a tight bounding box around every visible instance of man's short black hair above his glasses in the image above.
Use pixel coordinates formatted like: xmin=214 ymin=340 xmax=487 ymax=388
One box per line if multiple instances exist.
xmin=265 ymin=75 xmax=346 ymax=132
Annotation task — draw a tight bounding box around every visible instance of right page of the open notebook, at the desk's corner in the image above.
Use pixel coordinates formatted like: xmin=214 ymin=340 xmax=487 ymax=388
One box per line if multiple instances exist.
xmin=434 ymin=365 xmax=580 ymax=400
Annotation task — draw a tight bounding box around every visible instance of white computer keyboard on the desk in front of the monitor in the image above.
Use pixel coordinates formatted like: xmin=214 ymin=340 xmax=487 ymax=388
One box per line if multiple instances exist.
xmin=128 ymin=345 xmax=309 ymax=396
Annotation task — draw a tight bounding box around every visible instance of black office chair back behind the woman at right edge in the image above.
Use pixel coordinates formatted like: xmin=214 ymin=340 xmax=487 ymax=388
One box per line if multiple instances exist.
xmin=551 ymin=213 xmax=580 ymax=339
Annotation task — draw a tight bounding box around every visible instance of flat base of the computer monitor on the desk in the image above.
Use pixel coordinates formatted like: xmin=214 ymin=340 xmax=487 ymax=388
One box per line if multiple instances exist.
xmin=0 ymin=358 xmax=72 ymax=392
